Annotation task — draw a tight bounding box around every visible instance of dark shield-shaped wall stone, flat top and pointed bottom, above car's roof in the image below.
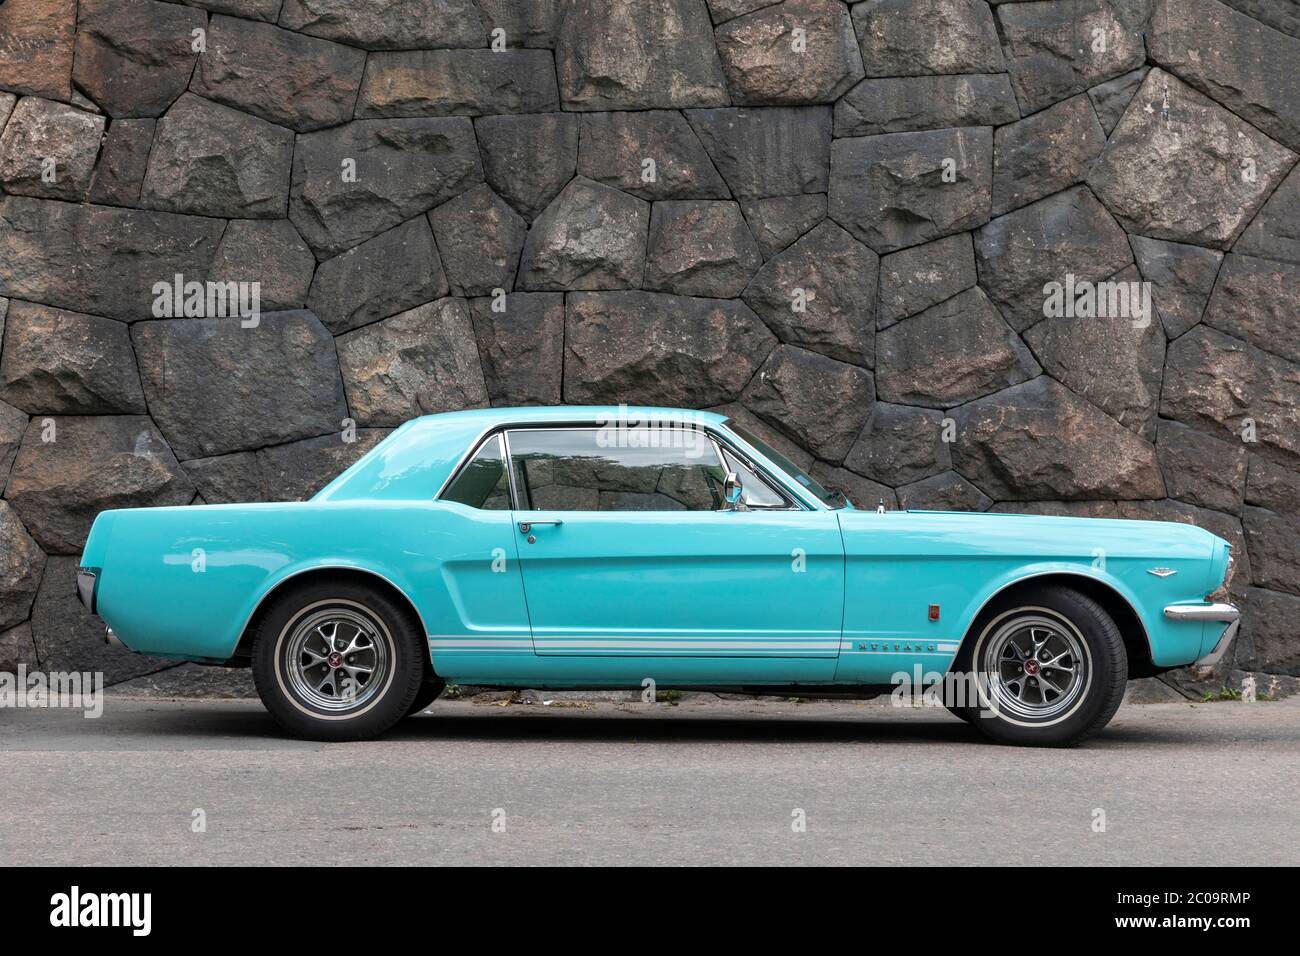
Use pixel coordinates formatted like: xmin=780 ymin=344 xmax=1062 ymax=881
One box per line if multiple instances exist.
xmin=475 ymin=113 xmax=579 ymax=220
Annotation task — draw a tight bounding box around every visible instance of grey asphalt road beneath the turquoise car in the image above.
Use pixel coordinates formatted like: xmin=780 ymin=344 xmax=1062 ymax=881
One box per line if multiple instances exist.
xmin=0 ymin=696 xmax=1300 ymax=865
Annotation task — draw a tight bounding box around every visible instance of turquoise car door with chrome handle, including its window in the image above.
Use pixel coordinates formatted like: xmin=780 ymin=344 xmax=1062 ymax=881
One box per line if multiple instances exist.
xmin=507 ymin=427 xmax=844 ymax=665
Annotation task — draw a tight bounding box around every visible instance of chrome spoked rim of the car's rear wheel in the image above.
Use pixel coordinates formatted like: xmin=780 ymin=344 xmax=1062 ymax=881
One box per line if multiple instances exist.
xmin=283 ymin=606 xmax=391 ymax=713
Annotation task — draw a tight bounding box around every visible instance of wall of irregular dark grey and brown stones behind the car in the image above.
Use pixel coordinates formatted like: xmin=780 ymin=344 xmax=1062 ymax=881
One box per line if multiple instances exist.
xmin=0 ymin=0 xmax=1300 ymax=688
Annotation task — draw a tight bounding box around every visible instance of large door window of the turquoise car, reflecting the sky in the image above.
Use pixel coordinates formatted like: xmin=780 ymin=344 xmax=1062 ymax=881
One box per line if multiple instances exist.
xmin=510 ymin=428 xmax=725 ymax=511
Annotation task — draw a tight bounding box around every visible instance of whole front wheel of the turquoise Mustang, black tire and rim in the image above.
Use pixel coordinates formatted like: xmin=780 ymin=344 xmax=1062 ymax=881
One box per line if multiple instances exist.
xmin=949 ymin=585 xmax=1128 ymax=747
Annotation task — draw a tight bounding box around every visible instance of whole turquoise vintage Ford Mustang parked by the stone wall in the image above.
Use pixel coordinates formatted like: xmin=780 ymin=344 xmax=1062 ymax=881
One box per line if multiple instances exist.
xmin=77 ymin=407 xmax=1238 ymax=745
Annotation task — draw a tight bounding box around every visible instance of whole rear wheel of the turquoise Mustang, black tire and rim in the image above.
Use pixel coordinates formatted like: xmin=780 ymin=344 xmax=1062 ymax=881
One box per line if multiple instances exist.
xmin=252 ymin=579 xmax=428 ymax=740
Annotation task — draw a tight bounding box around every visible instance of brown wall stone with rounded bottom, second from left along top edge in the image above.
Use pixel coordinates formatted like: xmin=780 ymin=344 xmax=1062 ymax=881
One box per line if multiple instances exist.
xmin=73 ymin=0 xmax=208 ymax=116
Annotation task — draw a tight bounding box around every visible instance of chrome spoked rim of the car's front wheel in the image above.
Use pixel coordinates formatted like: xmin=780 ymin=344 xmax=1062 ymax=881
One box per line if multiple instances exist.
xmin=983 ymin=615 xmax=1088 ymax=721
